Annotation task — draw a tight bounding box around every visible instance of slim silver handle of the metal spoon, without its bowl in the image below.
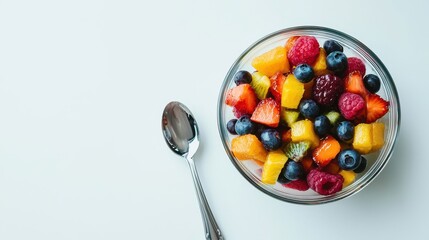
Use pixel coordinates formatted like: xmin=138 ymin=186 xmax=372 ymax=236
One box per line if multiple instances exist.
xmin=186 ymin=157 xmax=224 ymax=240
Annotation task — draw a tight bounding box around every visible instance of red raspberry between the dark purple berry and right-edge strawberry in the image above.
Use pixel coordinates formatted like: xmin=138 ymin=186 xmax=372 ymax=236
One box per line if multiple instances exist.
xmin=338 ymin=92 xmax=365 ymax=120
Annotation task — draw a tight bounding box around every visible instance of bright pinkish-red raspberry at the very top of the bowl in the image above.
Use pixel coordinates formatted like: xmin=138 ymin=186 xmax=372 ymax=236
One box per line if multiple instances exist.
xmin=287 ymin=36 xmax=319 ymax=66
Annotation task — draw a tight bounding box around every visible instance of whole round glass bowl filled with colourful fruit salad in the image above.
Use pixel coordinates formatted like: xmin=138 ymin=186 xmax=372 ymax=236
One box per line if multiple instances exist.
xmin=218 ymin=27 xmax=400 ymax=204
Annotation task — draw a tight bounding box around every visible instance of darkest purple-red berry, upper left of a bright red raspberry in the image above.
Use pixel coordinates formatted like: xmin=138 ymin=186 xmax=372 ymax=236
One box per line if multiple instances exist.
xmin=313 ymin=74 xmax=344 ymax=106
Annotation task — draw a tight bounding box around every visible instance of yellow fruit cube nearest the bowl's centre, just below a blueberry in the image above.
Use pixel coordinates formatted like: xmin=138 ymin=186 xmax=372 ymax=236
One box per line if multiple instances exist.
xmin=291 ymin=119 xmax=319 ymax=148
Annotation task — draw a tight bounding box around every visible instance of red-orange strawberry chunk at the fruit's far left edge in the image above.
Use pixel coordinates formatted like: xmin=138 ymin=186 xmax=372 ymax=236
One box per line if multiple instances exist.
xmin=225 ymin=84 xmax=258 ymax=114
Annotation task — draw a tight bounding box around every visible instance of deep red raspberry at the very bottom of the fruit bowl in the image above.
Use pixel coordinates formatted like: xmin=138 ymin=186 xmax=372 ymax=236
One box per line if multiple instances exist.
xmin=307 ymin=169 xmax=344 ymax=195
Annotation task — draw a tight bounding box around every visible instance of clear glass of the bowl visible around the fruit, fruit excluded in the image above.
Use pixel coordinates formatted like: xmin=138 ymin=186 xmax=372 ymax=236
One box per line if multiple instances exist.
xmin=218 ymin=26 xmax=400 ymax=204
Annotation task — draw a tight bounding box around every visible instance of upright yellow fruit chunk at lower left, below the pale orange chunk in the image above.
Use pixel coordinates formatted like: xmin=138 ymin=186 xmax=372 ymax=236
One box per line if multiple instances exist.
xmin=261 ymin=150 xmax=287 ymax=184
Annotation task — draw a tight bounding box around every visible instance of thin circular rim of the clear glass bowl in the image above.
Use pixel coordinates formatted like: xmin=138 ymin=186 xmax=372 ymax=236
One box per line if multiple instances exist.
xmin=217 ymin=25 xmax=401 ymax=205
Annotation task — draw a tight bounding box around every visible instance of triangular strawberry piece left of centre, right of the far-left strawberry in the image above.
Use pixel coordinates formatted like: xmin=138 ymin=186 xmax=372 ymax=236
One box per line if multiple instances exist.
xmin=250 ymin=98 xmax=280 ymax=127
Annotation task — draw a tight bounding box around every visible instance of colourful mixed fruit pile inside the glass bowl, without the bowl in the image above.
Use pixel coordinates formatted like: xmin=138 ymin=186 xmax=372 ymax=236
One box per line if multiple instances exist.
xmin=225 ymin=35 xmax=389 ymax=195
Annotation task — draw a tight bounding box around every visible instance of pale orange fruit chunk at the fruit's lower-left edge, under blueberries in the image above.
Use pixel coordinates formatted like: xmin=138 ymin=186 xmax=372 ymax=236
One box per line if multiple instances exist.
xmin=231 ymin=134 xmax=268 ymax=162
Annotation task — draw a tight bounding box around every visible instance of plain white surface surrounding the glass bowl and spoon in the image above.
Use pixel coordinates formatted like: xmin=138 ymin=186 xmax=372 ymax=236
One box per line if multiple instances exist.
xmin=0 ymin=0 xmax=429 ymax=240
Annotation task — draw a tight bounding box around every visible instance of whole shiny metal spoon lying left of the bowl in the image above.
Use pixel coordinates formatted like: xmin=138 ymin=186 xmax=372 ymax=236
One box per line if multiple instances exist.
xmin=162 ymin=102 xmax=224 ymax=240
